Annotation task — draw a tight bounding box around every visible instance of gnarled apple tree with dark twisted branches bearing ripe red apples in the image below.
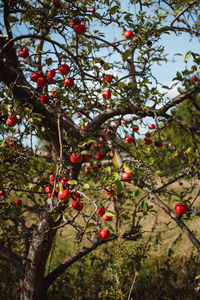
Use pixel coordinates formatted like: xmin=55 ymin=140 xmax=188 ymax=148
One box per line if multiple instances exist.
xmin=0 ymin=0 xmax=200 ymax=300
